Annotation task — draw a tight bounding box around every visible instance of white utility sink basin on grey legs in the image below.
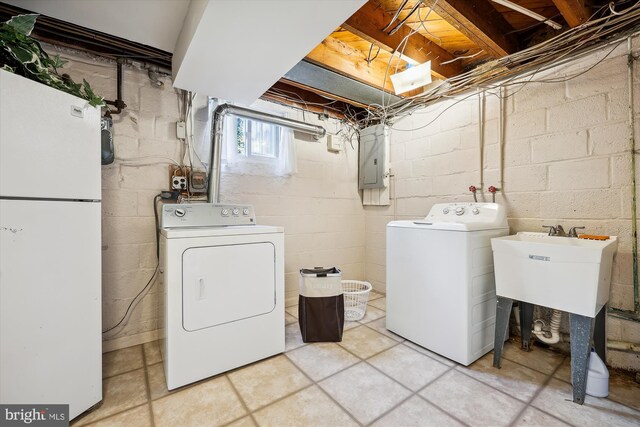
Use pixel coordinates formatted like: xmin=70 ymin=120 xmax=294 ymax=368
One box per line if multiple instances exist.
xmin=491 ymin=232 xmax=618 ymax=317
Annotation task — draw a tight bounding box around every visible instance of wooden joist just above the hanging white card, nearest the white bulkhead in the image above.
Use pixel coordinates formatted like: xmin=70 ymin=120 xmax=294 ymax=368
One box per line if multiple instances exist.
xmin=342 ymin=1 xmax=463 ymax=78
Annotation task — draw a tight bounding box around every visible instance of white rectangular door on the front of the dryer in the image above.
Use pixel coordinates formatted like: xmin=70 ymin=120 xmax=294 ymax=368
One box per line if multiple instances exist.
xmin=182 ymin=242 xmax=276 ymax=331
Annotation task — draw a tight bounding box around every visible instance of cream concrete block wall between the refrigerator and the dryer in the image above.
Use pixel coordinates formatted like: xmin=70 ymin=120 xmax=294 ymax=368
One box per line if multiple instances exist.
xmin=51 ymin=46 xmax=181 ymax=352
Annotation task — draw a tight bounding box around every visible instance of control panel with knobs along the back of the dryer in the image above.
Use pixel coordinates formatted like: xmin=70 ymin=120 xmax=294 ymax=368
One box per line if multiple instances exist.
xmin=162 ymin=203 xmax=256 ymax=228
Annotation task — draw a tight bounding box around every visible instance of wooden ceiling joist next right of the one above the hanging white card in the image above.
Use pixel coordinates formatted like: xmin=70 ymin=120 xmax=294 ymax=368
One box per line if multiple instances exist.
xmin=423 ymin=0 xmax=518 ymax=58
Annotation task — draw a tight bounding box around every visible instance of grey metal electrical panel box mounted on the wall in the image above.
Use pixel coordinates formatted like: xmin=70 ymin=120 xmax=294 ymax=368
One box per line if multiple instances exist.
xmin=358 ymin=125 xmax=389 ymax=190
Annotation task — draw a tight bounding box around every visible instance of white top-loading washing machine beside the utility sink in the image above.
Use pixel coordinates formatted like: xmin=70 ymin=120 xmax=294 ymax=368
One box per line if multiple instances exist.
xmin=387 ymin=203 xmax=509 ymax=366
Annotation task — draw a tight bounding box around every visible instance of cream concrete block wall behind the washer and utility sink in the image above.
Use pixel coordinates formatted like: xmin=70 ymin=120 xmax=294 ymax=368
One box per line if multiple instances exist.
xmin=365 ymin=37 xmax=640 ymax=370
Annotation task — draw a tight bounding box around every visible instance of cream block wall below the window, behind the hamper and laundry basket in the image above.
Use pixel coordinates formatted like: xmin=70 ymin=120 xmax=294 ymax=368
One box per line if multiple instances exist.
xmin=220 ymin=101 xmax=365 ymax=304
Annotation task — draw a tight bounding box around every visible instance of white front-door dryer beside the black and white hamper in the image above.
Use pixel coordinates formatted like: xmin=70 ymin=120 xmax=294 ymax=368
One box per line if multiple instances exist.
xmin=160 ymin=203 xmax=284 ymax=390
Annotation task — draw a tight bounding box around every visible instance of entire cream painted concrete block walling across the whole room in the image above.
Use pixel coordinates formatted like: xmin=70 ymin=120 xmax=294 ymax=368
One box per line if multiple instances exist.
xmin=47 ymin=38 xmax=640 ymax=369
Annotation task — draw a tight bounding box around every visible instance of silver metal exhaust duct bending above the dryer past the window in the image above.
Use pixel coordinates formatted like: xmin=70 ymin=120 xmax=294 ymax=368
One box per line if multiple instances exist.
xmin=207 ymin=104 xmax=327 ymax=203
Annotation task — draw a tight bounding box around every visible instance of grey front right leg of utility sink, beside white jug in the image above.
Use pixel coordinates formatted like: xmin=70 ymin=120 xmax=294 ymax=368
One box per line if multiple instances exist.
xmin=569 ymin=313 xmax=594 ymax=405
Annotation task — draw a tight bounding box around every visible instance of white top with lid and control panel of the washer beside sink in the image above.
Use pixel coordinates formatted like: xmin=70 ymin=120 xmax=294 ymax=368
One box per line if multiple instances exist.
xmin=388 ymin=202 xmax=509 ymax=232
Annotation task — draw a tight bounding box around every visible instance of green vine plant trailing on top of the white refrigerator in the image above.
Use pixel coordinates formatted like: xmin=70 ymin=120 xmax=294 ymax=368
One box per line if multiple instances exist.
xmin=0 ymin=14 xmax=105 ymax=107
